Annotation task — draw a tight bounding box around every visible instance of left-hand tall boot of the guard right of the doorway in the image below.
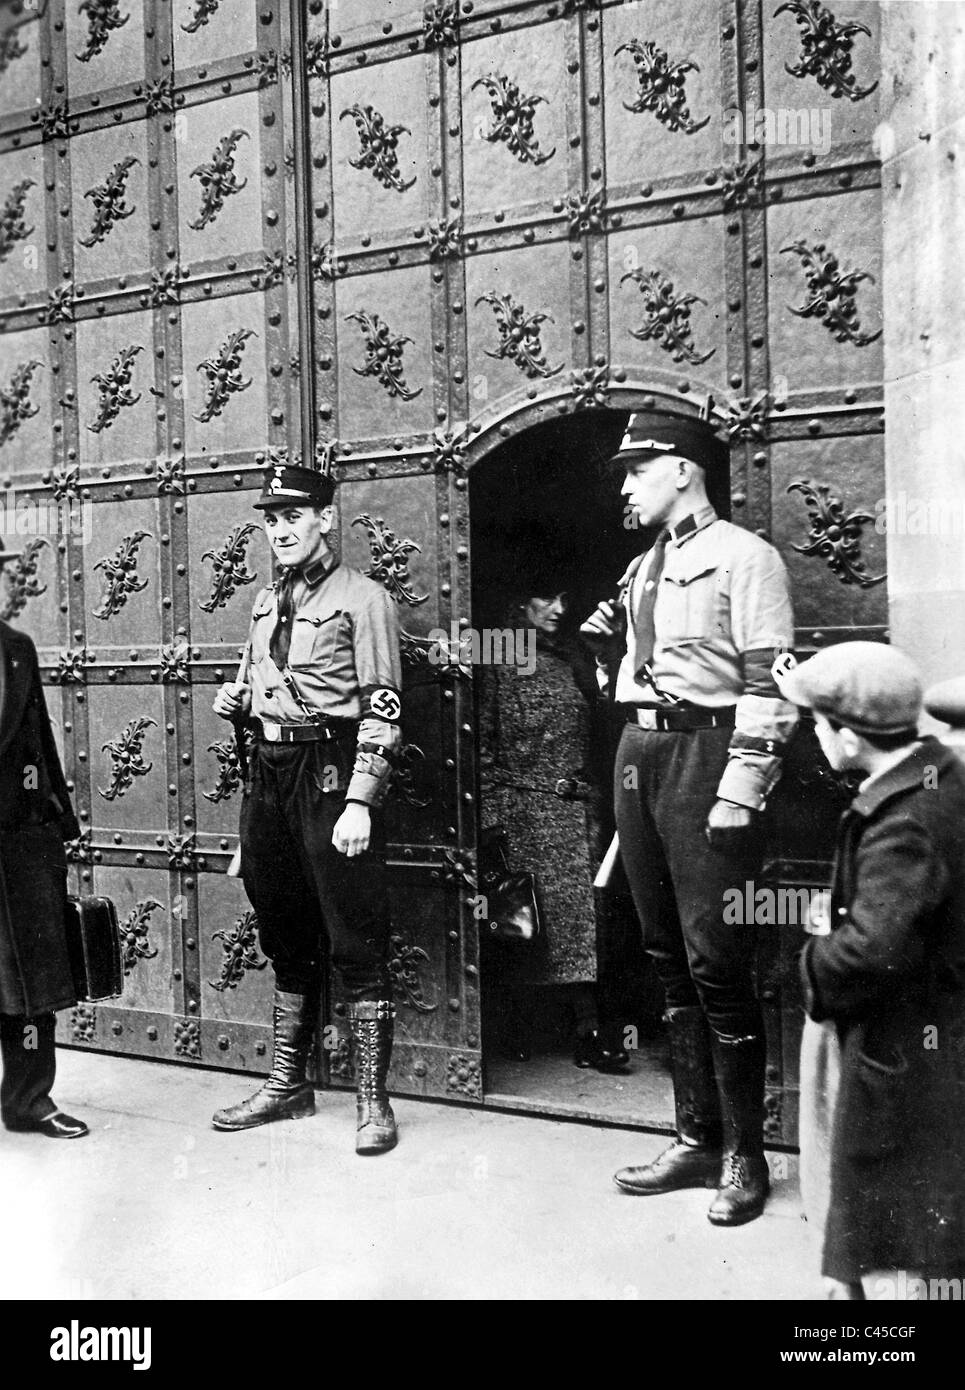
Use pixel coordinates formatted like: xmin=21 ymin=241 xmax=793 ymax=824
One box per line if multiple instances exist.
xmin=613 ymin=1006 xmax=720 ymax=1197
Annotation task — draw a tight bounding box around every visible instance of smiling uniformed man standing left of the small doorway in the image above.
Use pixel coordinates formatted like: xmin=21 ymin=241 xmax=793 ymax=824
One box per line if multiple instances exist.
xmin=213 ymin=464 xmax=402 ymax=1154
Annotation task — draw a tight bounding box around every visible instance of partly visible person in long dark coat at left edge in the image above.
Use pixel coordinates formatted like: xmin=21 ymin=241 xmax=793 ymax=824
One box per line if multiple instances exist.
xmin=0 ymin=589 xmax=88 ymax=1138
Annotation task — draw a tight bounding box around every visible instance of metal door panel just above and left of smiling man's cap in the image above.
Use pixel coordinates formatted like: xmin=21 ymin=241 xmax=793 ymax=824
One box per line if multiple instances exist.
xmin=181 ymin=293 xmax=267 ymax=459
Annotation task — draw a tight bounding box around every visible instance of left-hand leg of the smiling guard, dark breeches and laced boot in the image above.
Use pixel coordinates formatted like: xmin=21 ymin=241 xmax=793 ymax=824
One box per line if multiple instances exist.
xmin=211 ymin=745 xmax=321 ymax=1130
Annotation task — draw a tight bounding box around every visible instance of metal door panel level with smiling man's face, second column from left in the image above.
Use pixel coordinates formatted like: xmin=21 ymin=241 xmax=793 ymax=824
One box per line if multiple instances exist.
xmin=83 ymin=498 xmax=163 ymax=644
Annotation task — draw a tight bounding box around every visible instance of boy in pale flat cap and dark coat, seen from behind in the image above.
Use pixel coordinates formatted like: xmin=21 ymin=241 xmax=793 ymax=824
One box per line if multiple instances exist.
xmin=779 ymin=642 xmax=965 ymax=1298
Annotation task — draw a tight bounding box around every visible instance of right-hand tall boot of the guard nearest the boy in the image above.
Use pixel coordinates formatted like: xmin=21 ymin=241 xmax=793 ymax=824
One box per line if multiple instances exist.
xmin=708 ymin=1033 xmax=770 ymax=1226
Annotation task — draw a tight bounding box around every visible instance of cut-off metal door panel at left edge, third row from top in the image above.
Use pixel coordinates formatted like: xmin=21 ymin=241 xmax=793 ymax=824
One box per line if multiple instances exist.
xmin=0 ymin=328 xmax=57 ymax=482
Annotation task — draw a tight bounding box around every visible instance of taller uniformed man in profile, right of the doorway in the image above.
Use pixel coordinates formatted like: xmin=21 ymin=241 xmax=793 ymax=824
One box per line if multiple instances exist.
xmin=581 ymin=414 xmax=797 ymax=1226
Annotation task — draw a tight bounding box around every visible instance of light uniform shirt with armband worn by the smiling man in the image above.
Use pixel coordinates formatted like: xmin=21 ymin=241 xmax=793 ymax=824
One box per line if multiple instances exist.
xmin=249 ymin=563 xmax=402 ymax=805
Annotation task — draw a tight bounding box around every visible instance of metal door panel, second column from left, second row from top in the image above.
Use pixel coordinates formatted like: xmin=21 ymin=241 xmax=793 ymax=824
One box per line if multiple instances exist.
xmin=71 ymin=121 xmax=152 ymax=282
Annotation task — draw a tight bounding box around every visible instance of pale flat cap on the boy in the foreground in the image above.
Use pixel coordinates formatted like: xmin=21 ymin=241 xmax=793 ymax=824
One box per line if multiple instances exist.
xmin=775 ymin=642 xmax=922 ymax=734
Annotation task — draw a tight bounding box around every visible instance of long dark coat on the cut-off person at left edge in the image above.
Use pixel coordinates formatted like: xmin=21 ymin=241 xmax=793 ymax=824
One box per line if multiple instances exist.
xmin=0 ymin=621 xmax=79 ymax=1016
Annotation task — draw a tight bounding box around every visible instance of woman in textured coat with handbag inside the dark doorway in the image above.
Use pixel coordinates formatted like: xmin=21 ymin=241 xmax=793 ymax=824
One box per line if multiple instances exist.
xmin=480 ymin=571 xmax=629 ymax=1072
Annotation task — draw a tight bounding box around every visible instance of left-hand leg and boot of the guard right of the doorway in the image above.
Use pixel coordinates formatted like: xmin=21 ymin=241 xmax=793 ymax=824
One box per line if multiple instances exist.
xmin=613 ymin=726 xmax=720 ymax=1195
